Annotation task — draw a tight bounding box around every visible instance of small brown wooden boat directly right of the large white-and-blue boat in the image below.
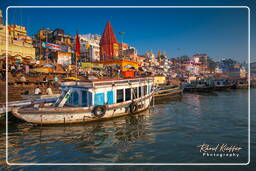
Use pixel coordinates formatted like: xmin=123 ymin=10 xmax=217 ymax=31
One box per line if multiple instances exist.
xmin=154 ymin=86 xmax=183 ymax=98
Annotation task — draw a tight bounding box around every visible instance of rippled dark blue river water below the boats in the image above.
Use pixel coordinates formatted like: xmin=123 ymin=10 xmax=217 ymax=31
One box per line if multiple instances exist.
xmin=0 ymin=89 xmax=256 ymax=170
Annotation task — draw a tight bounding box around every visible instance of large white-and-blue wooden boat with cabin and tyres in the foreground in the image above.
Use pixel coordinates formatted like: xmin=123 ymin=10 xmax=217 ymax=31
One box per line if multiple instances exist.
xmin=12 ymin=77 xmax=154 ymax=124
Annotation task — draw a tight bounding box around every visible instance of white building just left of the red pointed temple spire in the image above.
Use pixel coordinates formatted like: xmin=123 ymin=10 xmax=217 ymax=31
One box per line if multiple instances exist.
xmin=79 ymin=34 xmax=101 ymax=62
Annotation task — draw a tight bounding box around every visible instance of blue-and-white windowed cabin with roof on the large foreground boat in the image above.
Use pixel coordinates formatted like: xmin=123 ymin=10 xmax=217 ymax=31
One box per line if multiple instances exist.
xmin=61 ymin=78 xmax=153 ymax=107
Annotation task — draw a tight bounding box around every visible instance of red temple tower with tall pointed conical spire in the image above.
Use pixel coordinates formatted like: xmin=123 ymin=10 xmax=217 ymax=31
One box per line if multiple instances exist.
xmin=100 ymin=21 xmax=119 ymax=61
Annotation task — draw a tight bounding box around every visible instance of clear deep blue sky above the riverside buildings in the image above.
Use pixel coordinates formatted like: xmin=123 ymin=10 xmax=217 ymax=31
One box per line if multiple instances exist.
xmin=1 ymin=0 xmax=255 ymax=61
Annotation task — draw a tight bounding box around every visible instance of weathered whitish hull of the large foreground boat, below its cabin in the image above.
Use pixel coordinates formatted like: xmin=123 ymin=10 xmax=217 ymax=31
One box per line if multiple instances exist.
xmin=12 ymin=94 xmax=152 ymax=125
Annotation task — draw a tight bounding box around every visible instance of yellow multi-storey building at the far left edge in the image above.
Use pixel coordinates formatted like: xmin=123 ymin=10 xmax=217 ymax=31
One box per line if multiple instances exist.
xmin=0 ymin=13 xmax=35 ymax=59
